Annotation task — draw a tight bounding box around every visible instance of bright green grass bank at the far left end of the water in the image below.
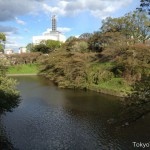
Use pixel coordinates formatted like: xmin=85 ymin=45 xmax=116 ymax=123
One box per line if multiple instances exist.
xmin=7 ymin=64 xmax=38 ymax=75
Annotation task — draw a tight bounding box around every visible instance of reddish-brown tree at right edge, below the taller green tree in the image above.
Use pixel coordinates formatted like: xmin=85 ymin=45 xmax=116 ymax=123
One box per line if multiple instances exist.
xmin=114 ymin=44 xmax=150 ymax=83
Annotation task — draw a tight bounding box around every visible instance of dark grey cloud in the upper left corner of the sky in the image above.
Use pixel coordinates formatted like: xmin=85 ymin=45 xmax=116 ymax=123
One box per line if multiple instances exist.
xmin=0 ymin=0 xmax=44 ymax=21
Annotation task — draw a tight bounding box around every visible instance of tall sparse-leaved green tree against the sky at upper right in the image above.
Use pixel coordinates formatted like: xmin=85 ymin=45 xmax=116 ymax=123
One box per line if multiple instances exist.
xmin=101 ymin=11 xmax=150 ymax=44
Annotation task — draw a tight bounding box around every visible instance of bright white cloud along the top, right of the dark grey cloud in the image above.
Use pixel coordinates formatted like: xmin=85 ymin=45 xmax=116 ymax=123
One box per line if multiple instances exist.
xmin=43 ymin=0 xmax=133 ymax=18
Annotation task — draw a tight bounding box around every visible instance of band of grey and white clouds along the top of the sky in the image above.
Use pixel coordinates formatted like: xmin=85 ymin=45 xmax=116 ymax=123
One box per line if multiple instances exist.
xmin=0 ymin=0 xmax=133 ymax=21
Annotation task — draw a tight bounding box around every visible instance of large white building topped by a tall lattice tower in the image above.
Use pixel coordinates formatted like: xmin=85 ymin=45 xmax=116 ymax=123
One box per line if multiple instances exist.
xmin=32 ymin=16 xmax=66 ymax=45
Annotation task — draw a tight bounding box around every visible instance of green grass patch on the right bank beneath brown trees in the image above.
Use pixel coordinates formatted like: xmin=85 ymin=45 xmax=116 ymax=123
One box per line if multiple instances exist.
xmin=89 ymin=63 xmax=131 ymax=96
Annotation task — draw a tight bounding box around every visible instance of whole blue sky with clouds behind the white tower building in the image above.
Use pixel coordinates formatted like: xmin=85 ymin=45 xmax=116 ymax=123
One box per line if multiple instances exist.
xmin=0 ymin=0 xmax=140 ymax=51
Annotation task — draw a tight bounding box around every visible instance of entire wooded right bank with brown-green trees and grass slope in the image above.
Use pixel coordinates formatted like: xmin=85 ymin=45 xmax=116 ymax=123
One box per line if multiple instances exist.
xmin=37 ymin=11 xmax=150 ymax=94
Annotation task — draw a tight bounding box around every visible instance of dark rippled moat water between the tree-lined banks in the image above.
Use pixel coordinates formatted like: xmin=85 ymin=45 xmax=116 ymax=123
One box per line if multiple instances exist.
xmin=0 ymin=77 xmax=150 ymax=150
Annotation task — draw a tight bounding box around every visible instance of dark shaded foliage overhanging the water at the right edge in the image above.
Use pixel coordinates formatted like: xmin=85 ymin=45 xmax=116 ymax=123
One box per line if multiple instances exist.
xmin=118 ymin=75 xmax=150 ymax=125
